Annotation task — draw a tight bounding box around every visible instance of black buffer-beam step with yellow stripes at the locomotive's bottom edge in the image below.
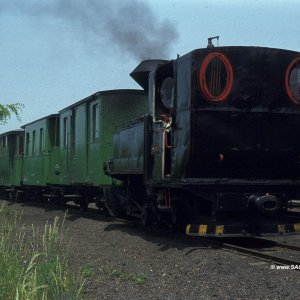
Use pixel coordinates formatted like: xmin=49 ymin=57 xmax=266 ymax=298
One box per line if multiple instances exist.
xmin=186 ymin=223 xmax=300 ymax=237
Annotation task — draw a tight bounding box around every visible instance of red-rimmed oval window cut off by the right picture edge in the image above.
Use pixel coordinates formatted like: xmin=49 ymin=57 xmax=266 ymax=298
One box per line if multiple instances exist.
xmin=285 ymin=57 xmax=300 ymax=105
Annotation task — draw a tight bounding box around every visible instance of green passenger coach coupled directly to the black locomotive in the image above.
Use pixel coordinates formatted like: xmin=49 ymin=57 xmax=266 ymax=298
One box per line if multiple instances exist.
xmin=59 ymin=90 xmax=148 ymax=207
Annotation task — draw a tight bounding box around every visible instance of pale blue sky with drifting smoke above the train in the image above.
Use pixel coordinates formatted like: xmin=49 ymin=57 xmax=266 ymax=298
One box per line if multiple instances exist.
xmin=0 ymin=0 xmax=300 ymax=132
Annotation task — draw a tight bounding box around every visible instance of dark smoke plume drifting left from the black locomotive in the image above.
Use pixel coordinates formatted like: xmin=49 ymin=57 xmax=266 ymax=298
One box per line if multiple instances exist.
xmin=0 ymin=0 xmax=178 ymax=59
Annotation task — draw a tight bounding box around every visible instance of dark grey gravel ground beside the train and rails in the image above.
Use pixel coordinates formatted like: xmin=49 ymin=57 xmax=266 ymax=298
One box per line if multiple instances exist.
xmin=0 ymin=200 xmax=300 ymax=300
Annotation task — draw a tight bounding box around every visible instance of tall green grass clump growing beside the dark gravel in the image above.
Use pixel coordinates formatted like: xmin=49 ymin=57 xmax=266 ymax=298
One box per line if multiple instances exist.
xmin=0 ymin=205 xmax=87 ymax=300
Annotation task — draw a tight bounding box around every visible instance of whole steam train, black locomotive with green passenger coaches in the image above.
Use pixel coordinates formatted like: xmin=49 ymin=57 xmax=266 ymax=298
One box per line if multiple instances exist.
xmin=0 ymin=46 xmax=300 ymax=236
